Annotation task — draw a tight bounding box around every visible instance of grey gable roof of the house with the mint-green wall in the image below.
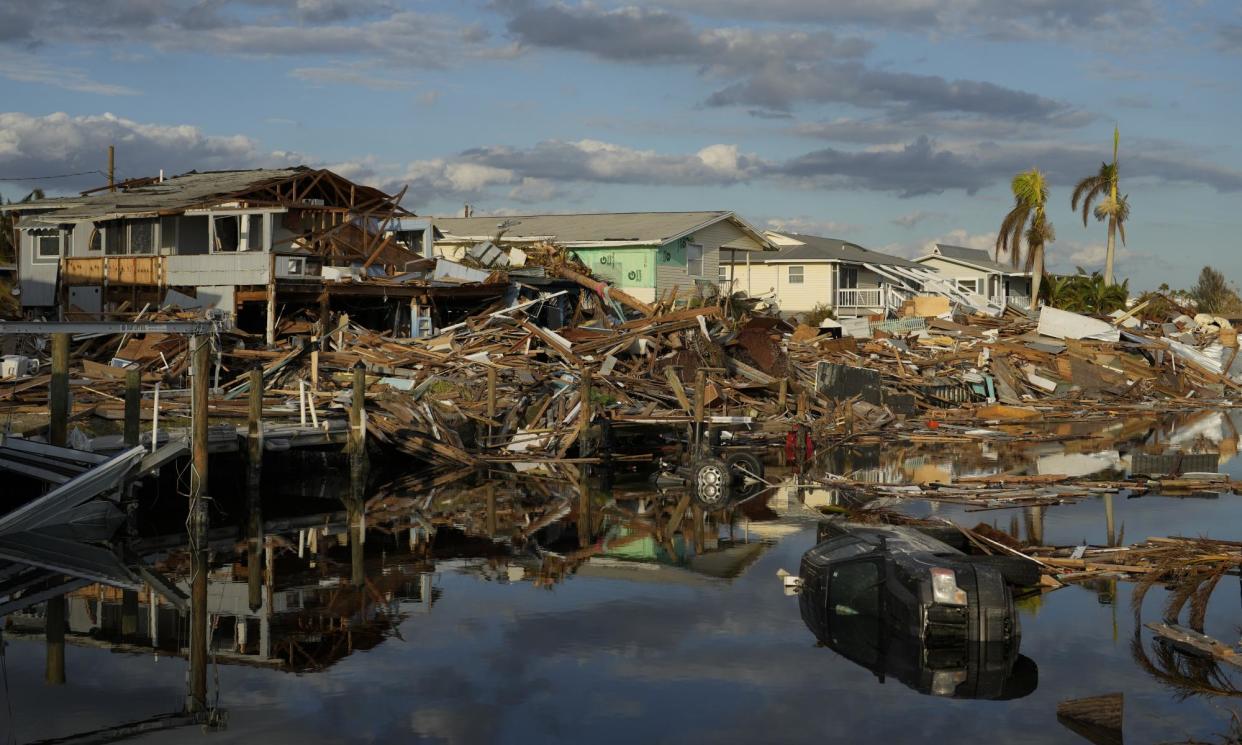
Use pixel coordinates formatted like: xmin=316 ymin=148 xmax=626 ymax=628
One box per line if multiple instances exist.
xmin=435 ymin=211 xmax=771 ymax=248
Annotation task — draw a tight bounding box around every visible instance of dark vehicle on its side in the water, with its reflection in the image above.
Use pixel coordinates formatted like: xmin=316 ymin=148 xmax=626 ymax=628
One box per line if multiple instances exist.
xmin=799 ymin=522 xmax=1038 ymax=699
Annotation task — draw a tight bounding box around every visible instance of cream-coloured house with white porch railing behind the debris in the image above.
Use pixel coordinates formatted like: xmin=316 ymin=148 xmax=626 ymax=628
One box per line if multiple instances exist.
xmin=720 ymin=232 xmax=934 ymax=317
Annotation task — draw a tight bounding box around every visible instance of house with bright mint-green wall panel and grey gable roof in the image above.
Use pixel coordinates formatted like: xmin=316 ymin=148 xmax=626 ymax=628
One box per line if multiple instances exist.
xmin=435 ymin=211 xmax=771 ymax=302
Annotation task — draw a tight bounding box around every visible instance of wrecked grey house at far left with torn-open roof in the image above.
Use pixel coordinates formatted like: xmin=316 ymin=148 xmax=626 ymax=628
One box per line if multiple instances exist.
xmin=0 ymin=166 xmax=503 ymax=340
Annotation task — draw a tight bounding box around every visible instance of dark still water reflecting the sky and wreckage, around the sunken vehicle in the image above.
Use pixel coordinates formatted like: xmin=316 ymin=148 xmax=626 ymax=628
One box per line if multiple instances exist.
xmin=0 ymin=412 xmax=1242 ymax=745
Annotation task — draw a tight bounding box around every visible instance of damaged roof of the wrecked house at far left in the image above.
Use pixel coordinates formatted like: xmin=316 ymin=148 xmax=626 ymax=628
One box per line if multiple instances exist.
xmin=9 ymin=165 xmax=390 ymax=224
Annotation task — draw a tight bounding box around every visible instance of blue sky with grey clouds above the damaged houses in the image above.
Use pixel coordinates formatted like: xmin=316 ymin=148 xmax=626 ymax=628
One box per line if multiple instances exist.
xmin=0 ymin=0 xmax=1242 ymax=288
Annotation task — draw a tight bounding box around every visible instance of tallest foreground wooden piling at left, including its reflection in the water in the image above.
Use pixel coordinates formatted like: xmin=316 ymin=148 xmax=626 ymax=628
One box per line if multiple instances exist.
xmin=186 ymin=336 xmax=211 ymax=714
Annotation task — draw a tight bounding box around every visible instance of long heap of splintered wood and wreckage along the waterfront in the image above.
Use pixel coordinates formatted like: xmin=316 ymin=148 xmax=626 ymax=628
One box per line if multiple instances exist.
xmin=7 ymin=245 xmax=1242 ymax=469
